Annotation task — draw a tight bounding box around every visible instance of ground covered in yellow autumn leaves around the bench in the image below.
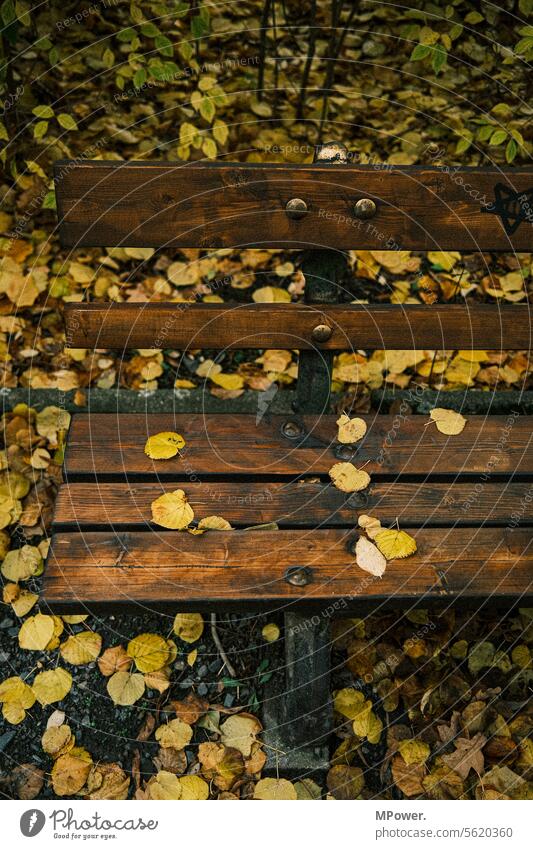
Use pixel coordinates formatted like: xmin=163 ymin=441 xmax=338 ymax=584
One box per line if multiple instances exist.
xmin=0 ymin=0 xmax=533 ymax=799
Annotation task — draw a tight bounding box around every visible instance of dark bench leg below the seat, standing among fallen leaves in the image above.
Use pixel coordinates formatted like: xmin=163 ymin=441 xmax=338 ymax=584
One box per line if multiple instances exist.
xmin=263 ymin=613 xmax=333 ymax=775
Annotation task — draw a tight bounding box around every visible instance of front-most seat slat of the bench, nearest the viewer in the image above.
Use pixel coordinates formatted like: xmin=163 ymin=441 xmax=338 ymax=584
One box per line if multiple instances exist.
xmin=44 ymin=528 xmax=533 ymax=612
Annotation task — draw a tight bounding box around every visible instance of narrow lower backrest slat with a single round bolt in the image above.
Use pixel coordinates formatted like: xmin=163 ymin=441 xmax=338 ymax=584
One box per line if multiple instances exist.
xmin=66 ymin=303 xmax=533 ymax=350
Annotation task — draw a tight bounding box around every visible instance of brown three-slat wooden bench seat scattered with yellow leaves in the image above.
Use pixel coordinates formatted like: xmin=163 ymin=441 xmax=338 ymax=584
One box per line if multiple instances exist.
xmin=44 ymin=413 xmax=533 ymax=613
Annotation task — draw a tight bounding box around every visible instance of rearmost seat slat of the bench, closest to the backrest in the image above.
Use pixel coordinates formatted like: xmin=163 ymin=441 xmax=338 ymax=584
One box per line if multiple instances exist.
xmin=65 ymin=410 xmax=533 ymax=476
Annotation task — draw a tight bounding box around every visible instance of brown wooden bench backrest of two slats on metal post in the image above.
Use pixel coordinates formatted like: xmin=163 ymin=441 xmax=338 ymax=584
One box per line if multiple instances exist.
xmin=55 ymin=143 xmax=533 ymax=398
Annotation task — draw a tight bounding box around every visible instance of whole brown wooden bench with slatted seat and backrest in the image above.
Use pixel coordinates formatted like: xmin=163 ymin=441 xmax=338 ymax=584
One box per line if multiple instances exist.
xmin=44 ymin=143 xmax=533 ymax=768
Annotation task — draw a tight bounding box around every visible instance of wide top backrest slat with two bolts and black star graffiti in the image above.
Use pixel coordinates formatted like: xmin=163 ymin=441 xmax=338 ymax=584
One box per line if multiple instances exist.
xmin=55 ymin=161 xmax=533 ymax=250
